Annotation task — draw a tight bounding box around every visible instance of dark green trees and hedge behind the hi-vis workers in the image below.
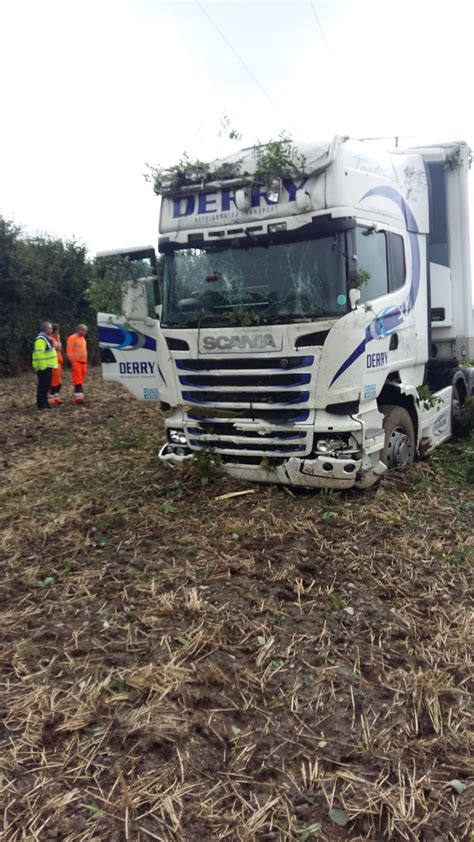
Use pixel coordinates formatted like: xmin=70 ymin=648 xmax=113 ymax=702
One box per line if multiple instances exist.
xmin=0 ymin=216 xmax=150 ymax=376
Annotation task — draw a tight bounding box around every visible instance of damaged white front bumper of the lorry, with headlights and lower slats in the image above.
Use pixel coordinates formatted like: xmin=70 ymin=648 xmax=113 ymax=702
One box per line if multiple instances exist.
xmin=160 ymin=402 xmax=386 ymax=489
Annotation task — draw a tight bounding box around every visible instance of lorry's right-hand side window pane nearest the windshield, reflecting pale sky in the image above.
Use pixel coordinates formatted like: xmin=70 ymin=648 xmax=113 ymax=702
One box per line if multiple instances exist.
xmin=355 ymin=226 xmax=388 ymax=301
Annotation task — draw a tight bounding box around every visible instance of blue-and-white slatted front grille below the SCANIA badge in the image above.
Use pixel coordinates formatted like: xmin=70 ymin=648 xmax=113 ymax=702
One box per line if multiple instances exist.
xmin=176 ymin=355 xmax=314 ymax=465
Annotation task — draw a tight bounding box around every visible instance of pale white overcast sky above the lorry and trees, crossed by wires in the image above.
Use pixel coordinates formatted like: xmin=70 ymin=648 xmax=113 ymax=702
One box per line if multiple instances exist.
xmin=0 ymin=0 xmax=474 ymax=253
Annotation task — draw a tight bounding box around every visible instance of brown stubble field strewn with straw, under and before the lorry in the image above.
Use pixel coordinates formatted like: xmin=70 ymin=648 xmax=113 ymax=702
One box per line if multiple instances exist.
xmin=0 ymin=372 xmax=474 ymax=842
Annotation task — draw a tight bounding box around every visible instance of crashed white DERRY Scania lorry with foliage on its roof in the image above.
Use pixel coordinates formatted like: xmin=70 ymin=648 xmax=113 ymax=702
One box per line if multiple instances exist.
xmin=98 ymin=137 xmax=474 ymax=488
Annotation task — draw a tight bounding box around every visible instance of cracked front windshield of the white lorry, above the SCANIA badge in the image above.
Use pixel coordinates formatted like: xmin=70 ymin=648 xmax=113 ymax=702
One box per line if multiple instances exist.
xmin=162 ymin=226 xmax=347 ymax=327
